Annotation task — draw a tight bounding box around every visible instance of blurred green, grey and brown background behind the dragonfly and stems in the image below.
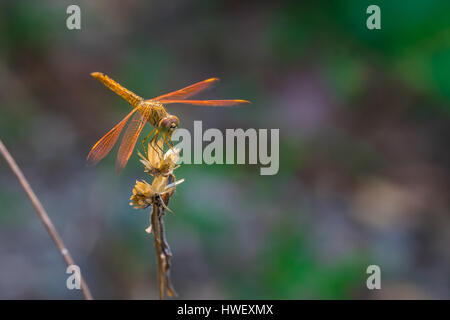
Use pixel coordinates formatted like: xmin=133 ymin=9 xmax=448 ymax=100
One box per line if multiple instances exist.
xmin=0 ymin=0 xmax=450 ymax=299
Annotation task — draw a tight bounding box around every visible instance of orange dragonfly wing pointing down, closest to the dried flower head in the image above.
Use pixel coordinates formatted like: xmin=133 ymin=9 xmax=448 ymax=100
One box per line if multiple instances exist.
xmin=116 ymin=108 xmax=150 ymax=173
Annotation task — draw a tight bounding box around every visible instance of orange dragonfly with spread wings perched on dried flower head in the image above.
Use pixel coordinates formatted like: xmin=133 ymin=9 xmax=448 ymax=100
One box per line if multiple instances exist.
xmin=87 ymin=72 xmax=250 ymax=172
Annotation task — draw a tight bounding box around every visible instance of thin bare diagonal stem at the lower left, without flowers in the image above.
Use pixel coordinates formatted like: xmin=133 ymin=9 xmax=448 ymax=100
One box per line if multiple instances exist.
xmin=0 ymin=139 xmax=92 ymax=300
